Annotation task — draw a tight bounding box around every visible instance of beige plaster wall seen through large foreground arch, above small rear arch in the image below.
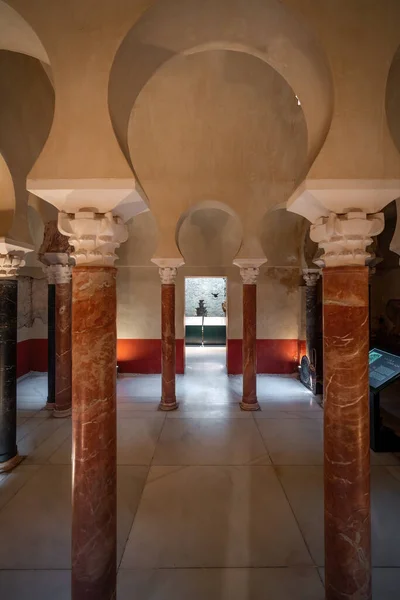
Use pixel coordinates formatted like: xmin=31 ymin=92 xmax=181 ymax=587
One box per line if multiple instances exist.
xmin=128 ymin=50 xmax=307 ymax=257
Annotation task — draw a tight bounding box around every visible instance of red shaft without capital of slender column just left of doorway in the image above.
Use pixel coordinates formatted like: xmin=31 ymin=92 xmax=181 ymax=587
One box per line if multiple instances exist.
xmin=160 ymin=283 xmax=178 ymax=410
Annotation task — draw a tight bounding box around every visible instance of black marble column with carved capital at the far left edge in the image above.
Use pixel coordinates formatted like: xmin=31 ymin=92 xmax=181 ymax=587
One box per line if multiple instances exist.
xmin=0 ymin=254 xmax=27 ymax=473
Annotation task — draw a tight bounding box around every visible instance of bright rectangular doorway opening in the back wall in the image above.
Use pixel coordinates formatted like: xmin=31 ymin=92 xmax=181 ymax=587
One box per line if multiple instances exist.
xmin=185 ymin=277 xmax=228 ymax=373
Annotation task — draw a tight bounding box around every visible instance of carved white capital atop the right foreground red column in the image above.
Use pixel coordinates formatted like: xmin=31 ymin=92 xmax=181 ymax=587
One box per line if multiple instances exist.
xmin=310 ymin=211 xmax=385 ymax=267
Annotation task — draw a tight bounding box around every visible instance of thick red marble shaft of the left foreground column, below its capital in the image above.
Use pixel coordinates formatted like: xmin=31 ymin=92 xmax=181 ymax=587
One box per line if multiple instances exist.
xmin=72 ymin=266 xmax=117 ymax=600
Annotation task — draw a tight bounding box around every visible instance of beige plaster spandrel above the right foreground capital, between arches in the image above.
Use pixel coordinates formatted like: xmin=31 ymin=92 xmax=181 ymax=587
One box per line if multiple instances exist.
xmin=284 ymin=0 xmax=400 ymax=180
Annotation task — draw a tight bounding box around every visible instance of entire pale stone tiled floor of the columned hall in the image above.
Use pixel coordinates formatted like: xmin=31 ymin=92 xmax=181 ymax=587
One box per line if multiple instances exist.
xmin=0 ymin=348 xmax=400 ymax=600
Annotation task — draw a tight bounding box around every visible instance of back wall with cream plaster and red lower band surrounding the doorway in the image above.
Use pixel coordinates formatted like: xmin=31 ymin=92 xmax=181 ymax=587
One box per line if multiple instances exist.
xmin=117 ymin=266 xmax=301 ymax=372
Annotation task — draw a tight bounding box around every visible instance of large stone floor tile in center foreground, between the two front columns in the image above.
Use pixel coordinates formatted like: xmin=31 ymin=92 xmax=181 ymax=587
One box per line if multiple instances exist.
xmin=121 ymin=466 xmax=312 ymax=569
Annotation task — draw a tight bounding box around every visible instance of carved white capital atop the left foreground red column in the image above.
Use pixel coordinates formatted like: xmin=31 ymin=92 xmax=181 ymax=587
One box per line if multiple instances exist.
xmin=58 ymin=211 xmax=128 ymax=267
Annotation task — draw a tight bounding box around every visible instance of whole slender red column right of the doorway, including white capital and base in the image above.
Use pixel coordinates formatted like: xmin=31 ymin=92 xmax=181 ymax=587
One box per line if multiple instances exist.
xmin=234 ymin=259 xmax=265 ymax=411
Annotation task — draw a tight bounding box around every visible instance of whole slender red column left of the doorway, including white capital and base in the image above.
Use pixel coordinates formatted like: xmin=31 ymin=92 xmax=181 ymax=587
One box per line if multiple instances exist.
xmin=153 ymin=259 xmax=182 ymax=411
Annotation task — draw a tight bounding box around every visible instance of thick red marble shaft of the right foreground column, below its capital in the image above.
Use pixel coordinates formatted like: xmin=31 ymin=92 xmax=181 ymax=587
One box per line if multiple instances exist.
xmin=323 ymin=266 xmax=372 ymax=600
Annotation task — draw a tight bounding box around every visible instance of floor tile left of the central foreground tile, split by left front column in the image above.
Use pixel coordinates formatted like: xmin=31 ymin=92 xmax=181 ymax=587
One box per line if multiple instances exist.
xmin=0 ymin=465 xmax=148 ymax=569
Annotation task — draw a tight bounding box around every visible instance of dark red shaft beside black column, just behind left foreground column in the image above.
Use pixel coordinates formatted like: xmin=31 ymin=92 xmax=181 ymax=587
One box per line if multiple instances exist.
xmin=54 ymin=282 xmax=72 ymax=417
